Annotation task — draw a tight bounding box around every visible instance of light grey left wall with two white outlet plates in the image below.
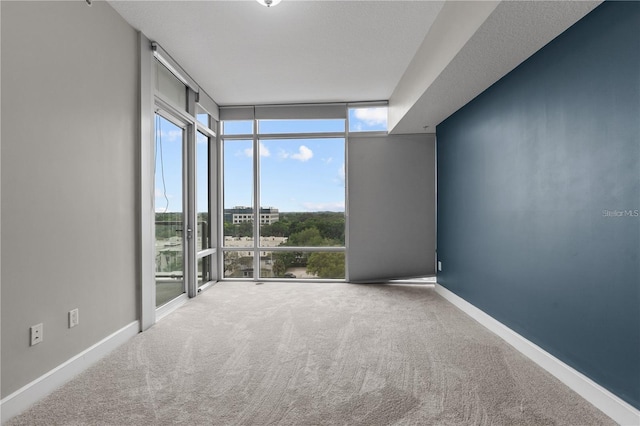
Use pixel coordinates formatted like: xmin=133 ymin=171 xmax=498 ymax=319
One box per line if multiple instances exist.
xmin=1 ymin=1 xmax=139 ymax=397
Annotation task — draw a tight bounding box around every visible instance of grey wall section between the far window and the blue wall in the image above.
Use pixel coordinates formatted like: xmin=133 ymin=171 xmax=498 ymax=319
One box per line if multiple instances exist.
xmin=347 ymin=134 xmax=436 ymax=282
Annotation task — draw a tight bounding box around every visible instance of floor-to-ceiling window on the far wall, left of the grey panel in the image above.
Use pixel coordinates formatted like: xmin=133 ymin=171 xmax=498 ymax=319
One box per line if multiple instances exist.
xmin=221 ymin=104 xmax=346 ymax=280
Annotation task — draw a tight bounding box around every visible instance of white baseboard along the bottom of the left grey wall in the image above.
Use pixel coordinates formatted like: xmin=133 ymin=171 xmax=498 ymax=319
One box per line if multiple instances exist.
xmin=0 ymin=321 xmax=140 ymax=423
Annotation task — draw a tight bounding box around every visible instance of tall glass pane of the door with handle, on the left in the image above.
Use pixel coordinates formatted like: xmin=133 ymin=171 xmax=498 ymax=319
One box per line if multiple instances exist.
xmin=155 ymin=115 xmax=185 ymax=306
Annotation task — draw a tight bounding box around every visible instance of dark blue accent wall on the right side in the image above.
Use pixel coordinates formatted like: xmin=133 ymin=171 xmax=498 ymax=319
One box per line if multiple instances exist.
xmin=436 ymin=2 xmax=640 ymax=408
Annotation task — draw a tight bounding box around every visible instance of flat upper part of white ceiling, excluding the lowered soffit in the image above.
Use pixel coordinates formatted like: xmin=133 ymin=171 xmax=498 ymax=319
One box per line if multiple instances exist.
xmin=110 ymin=0 xmax=442 ymax=105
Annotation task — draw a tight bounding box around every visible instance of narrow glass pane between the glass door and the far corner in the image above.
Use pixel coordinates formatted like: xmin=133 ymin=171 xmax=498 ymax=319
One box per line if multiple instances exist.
xmin=196 ymin=132 xmax=211 ymax=251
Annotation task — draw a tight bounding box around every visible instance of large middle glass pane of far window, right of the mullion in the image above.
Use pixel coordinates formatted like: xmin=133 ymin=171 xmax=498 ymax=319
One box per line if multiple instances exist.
xmin=260 ymin=138 xmax=345 ymax=247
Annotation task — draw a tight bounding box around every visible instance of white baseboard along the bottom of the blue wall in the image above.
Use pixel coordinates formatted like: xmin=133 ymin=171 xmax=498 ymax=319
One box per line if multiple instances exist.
xmin=435 ymin=284 xmax=640 ymax=426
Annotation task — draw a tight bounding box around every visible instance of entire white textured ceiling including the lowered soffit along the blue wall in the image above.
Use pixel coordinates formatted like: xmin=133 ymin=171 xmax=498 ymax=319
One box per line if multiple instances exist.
xmin=109 ymin=0 xmax=601 ymax=133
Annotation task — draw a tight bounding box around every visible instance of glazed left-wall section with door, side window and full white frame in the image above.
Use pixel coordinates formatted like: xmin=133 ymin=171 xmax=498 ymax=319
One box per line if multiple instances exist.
xmin=140 ymin=40 xmax=219 ymax=330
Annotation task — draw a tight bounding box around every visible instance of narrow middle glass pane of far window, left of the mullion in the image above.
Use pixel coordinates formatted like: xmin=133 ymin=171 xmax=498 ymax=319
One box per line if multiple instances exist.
xmin=223 ymin=140 xmax=253 ymax=247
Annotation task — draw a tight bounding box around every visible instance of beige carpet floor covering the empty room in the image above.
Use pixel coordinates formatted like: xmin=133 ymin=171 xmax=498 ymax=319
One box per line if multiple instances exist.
xmin=8 ymin=282 xmax=614 ymax=426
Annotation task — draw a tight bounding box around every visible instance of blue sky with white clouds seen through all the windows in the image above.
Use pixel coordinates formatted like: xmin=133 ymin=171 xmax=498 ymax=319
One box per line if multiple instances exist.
xmin=155 ymin=108 xmax=387 ymax=212
